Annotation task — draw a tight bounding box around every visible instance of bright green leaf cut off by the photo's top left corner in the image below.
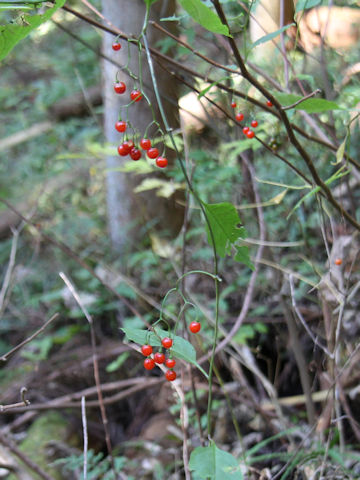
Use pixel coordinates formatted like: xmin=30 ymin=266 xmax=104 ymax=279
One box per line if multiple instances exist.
xmin=0 ymin=0 xmax=66 ymax=61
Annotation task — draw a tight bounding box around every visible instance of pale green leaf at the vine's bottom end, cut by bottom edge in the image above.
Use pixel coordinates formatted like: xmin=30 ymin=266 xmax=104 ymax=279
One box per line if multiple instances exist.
xmin=189 ymin=442 xmax=243 ymax=480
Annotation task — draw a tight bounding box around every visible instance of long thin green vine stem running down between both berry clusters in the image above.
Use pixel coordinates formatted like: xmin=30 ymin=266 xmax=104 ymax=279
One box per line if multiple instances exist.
xmin=139 ymin=16 xmax=219 ymax=438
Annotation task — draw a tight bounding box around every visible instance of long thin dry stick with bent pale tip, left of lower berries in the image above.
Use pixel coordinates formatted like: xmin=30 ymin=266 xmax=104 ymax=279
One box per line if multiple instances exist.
xmin=59 ymin=272 xmax=116 ymax=478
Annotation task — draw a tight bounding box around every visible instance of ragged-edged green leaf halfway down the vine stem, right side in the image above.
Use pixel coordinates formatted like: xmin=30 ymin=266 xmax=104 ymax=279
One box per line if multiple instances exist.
xmin=203 ymin=202 xmax=253 ymax=268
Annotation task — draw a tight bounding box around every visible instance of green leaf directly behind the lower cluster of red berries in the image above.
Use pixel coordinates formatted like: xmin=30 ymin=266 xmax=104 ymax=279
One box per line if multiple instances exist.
xmin=121 ymin=327 xmax=208 ymax=378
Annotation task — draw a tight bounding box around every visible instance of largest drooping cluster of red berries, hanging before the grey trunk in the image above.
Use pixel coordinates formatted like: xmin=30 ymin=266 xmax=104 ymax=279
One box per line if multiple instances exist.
xmin=112 ymin=41 xmax=168 ymax=168
